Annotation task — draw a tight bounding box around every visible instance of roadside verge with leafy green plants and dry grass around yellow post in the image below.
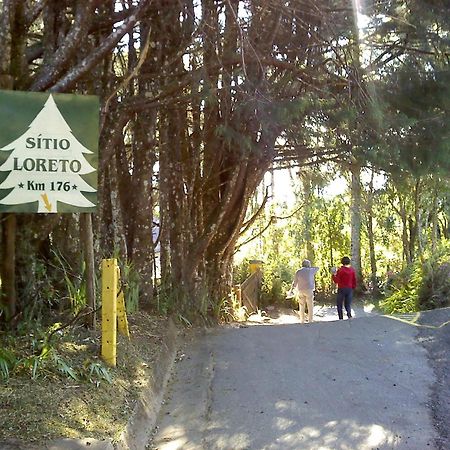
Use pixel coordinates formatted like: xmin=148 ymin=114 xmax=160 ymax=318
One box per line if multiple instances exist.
xmin=0 ymin=311 xmax=169 ymax=442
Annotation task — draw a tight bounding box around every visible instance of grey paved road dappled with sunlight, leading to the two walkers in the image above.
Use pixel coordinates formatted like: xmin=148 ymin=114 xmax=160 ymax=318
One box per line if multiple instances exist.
xmin=149 ymin=309 xmax=435 ymax=450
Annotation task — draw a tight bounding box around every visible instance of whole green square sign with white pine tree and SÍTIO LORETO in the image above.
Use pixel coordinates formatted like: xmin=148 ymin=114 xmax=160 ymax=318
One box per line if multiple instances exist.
xmin=0 ymin=91 xmax=99 ymax=213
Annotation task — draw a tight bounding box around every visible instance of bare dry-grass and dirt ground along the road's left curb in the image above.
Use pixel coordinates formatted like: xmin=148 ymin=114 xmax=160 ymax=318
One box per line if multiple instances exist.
xmin=0 ymin=312 xmax=179 ymax=449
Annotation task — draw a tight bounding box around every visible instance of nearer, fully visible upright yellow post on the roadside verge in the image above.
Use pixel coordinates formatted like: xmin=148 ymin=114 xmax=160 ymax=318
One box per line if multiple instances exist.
xmin=102 ymin=258 xmax=117 ymax=367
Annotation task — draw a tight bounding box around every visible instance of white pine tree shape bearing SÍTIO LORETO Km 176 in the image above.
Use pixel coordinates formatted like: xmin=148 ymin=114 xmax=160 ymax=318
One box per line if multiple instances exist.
xmin=0 ymin=94 xmax=96 ymax=213
